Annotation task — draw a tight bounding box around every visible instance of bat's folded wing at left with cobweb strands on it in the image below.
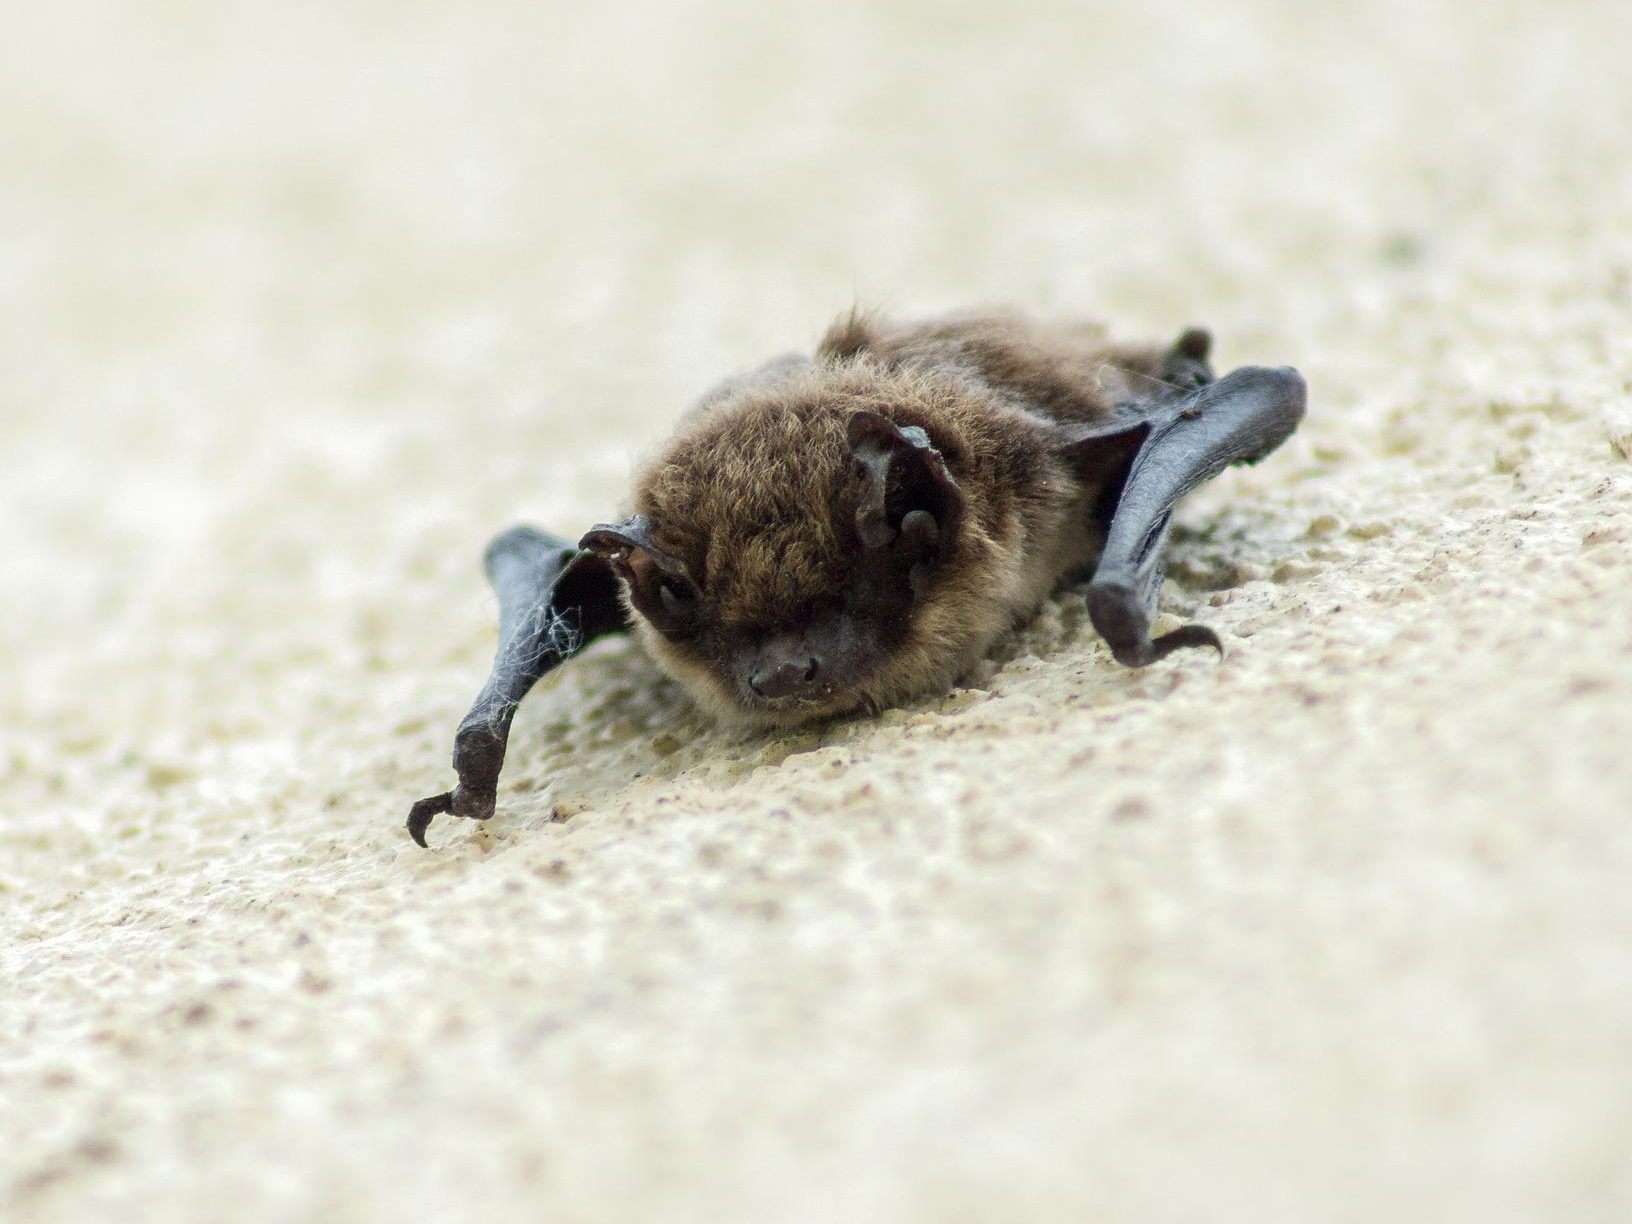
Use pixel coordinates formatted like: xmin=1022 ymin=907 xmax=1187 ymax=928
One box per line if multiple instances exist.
xmin=408 ymin=527 xmax=627 ymax=845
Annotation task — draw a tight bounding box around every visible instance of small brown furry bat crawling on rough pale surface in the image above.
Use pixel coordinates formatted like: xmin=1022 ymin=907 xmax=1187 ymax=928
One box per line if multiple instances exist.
xmin=408 ymin=313 xmax=1304 ymax=845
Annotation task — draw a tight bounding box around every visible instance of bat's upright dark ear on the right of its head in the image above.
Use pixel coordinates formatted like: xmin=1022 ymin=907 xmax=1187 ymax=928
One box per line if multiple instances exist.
xmin=849 ymin=411 xmax=963 ymax=565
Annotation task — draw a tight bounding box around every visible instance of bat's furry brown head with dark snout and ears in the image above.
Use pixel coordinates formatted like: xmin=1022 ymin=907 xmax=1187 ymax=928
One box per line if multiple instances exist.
xmin=583 ymin=363 xmax=1024 ymax=725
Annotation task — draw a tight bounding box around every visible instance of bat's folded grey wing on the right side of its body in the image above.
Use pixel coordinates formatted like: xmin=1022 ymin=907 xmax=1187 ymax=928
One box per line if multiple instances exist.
xmin=1058 ymin=366 xmax=1307 ymax=667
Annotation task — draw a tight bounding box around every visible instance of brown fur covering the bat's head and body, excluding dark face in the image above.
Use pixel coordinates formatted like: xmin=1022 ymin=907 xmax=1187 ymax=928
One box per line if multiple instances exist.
xmin=632 ymin=313 xmax=1164 ymax=723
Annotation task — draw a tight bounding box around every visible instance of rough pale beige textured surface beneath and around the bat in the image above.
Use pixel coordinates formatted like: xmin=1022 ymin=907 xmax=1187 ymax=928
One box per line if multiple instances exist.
xmin=0 ymin=0 xmax=1632 ymax=1224
